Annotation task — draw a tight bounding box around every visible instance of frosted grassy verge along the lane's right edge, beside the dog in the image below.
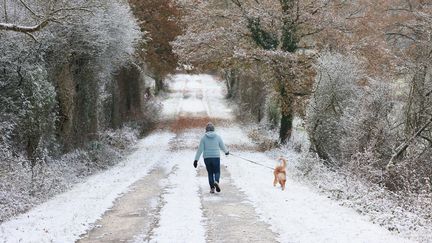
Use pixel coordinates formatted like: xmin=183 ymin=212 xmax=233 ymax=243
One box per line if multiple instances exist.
xmin=248 ymin=119 xmax=432 ymax=242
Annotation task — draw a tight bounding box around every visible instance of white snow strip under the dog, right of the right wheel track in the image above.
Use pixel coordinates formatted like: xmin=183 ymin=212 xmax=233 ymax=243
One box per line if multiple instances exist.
xmin=226 ymin=152 xmax=410 ymax=243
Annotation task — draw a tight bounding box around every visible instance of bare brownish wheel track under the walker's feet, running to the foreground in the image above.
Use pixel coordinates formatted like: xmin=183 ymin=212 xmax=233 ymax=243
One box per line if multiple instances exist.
xmin=199 ymin=166 xmax=277 ymax=243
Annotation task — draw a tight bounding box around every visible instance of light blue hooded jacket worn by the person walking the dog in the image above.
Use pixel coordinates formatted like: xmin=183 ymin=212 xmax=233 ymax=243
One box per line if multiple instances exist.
xmin=195 ymin=131 xmax=228 ymax=160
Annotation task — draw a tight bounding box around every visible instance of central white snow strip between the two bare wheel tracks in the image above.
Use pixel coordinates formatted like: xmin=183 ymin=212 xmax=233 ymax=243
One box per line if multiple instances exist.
xmin=150 ymin=151 xmax=205 ymax=243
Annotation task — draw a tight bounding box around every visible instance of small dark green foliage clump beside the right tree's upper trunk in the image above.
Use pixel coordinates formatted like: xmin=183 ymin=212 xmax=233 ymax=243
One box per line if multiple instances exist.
xmin=248 ymin=18 xmax=279 ymax=50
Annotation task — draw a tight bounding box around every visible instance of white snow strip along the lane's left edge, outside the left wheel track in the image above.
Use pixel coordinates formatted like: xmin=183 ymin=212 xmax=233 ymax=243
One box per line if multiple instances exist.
xmin=0 ymin=133 xmax=174 ymax=243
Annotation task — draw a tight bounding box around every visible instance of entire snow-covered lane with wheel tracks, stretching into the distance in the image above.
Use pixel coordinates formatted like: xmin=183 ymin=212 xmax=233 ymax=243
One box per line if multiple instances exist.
xmin=0 ymin=75 xmax=409 ymax=243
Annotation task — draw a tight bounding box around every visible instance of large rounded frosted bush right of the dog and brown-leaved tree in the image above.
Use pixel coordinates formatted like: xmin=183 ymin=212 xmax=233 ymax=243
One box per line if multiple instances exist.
xmin=306 ymin=52 xmax=395 ymax=167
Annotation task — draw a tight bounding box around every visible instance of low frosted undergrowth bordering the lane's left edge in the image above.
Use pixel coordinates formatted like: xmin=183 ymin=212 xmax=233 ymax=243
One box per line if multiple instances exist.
xmin=0 ymin=127 xmax=139 ymax=222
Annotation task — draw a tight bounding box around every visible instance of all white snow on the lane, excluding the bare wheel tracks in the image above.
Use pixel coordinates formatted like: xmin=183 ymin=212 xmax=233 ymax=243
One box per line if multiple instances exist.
xmin=0 ymin=75 xmax=416 ymax=242
